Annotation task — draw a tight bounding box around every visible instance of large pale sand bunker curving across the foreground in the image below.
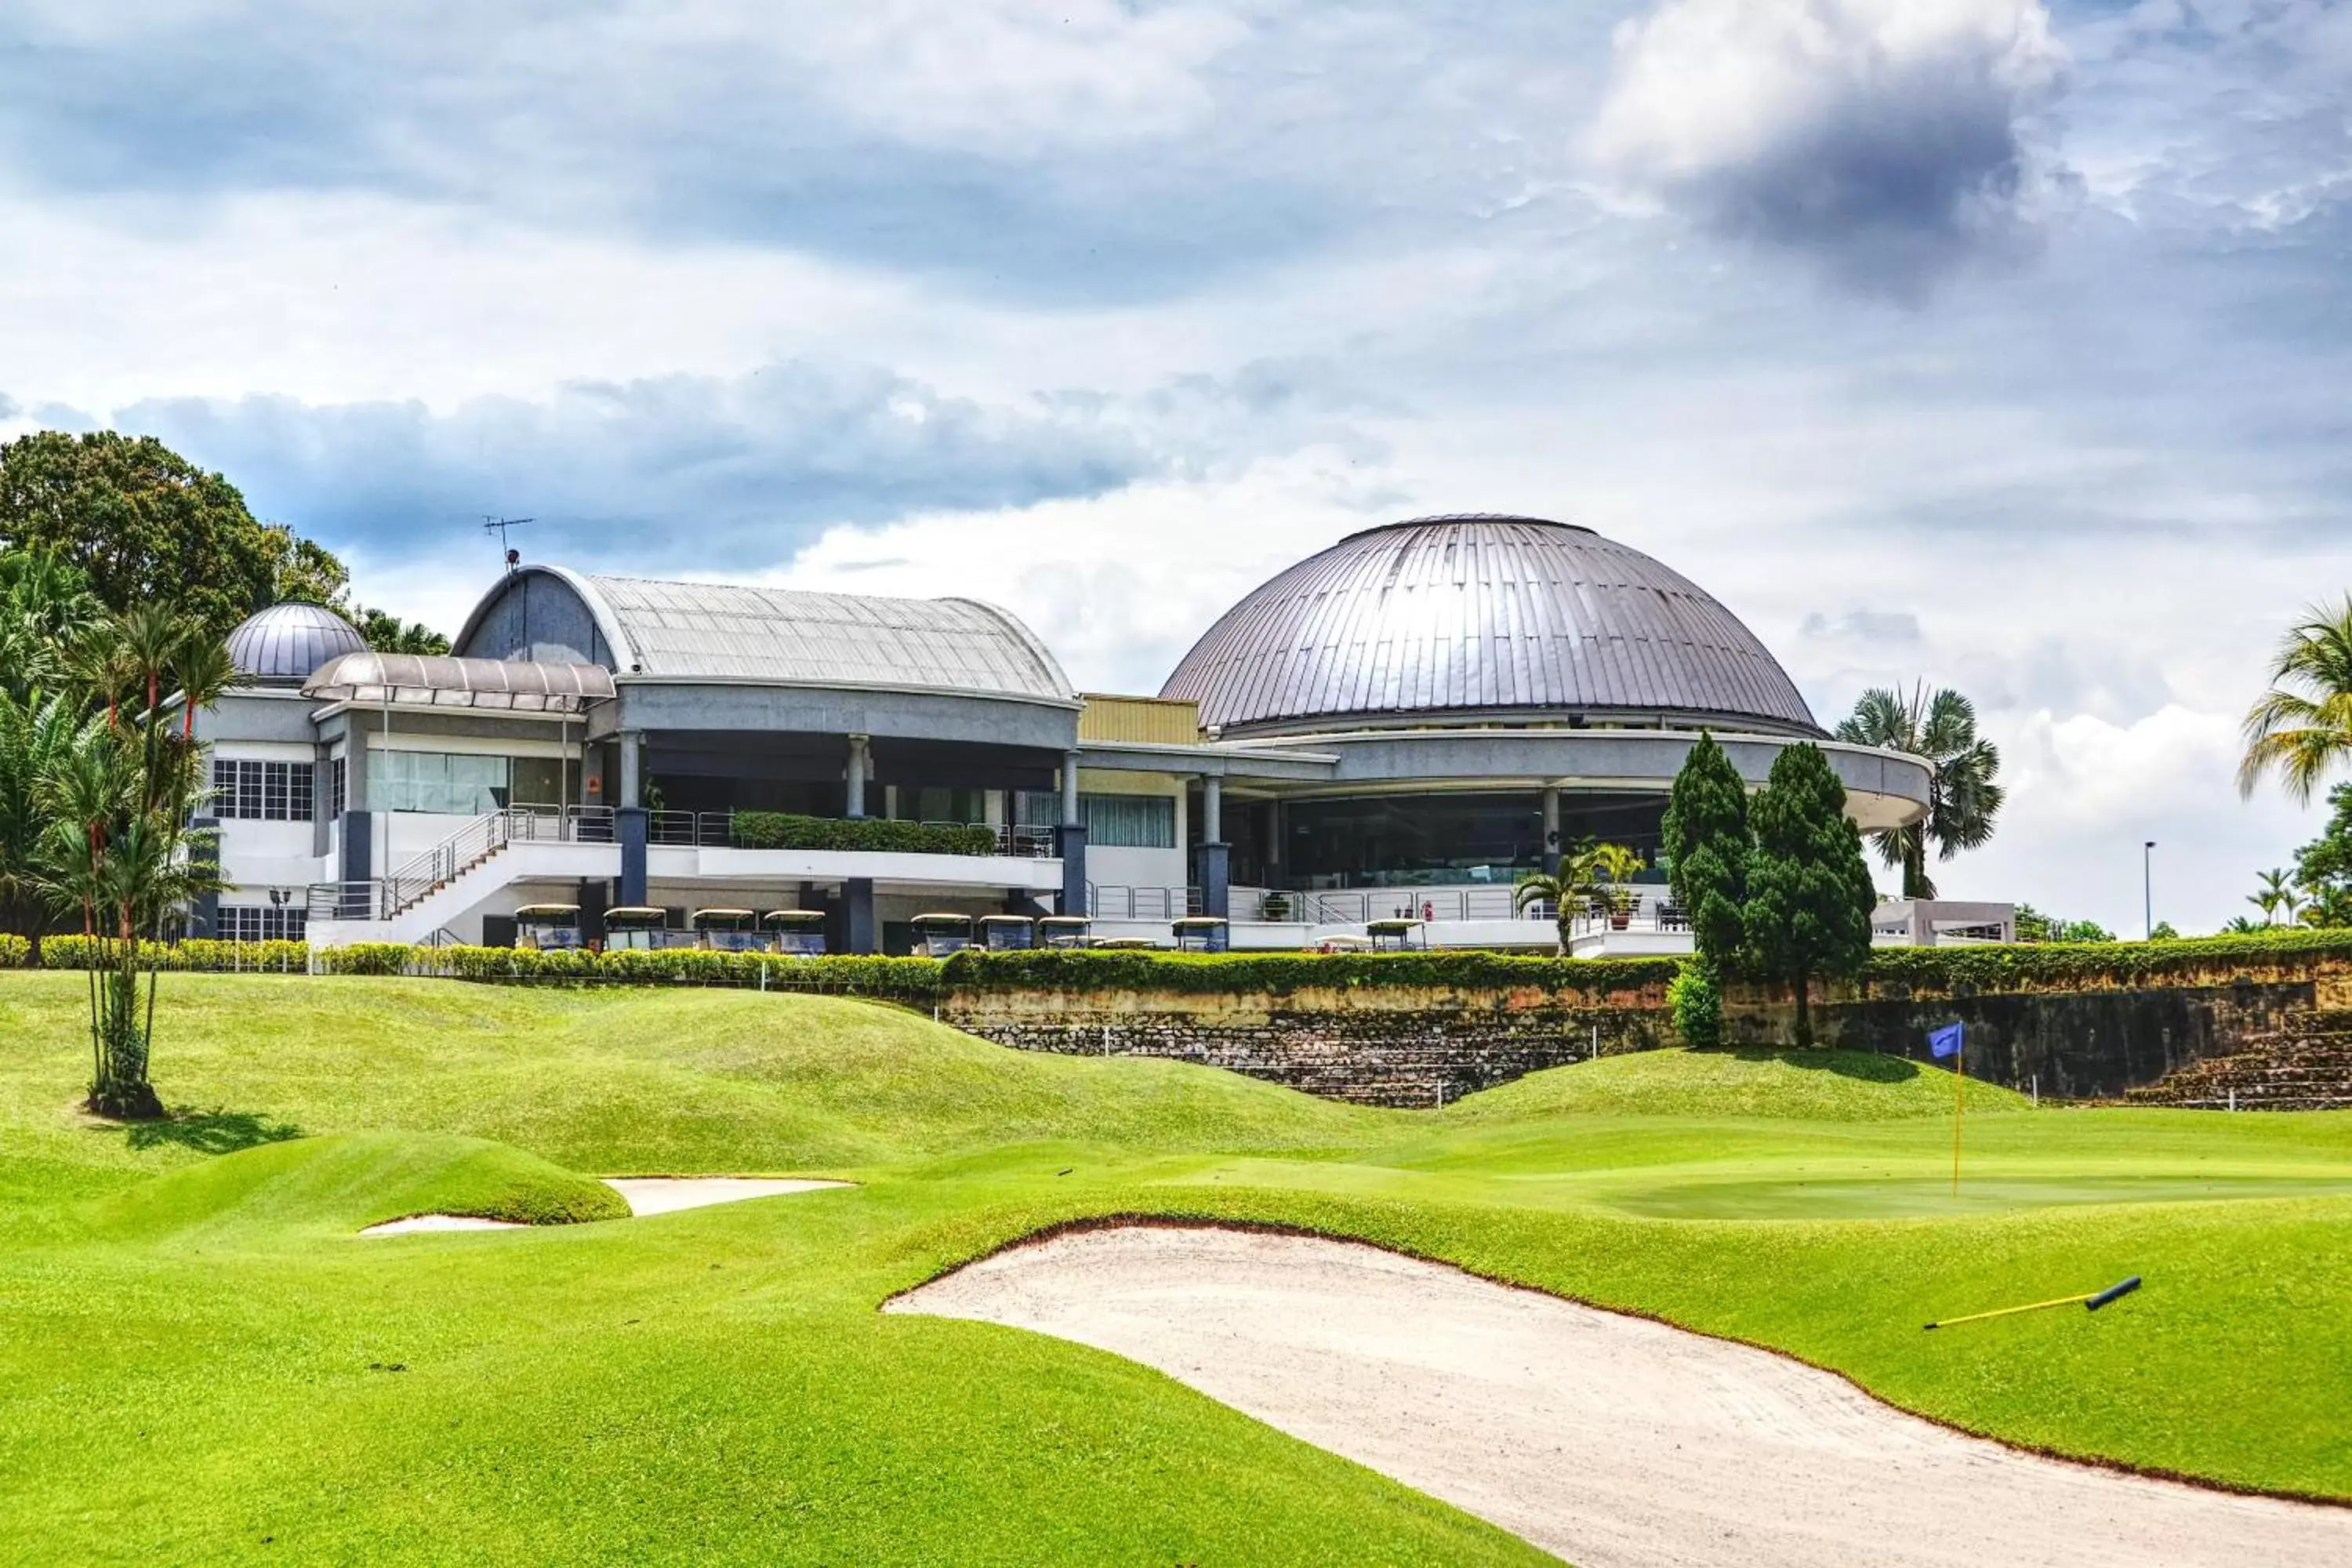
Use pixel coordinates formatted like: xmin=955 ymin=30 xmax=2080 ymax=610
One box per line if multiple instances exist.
xmin=884 ymin=1227 xmax=2352 ymax=1568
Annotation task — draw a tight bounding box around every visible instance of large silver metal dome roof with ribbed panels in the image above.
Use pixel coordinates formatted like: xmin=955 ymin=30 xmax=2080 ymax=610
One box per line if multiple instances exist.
xmin=1160 ymin=515 xmax=1820 ymax=736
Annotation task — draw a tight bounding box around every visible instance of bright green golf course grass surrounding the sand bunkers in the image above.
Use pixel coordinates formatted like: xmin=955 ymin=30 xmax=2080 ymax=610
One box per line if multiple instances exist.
xmin=0 ymin=973 xmax=2352 ymax=1563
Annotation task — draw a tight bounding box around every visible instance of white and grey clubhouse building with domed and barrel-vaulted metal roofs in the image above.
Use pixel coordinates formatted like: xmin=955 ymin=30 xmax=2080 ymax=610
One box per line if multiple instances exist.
xmin=195 ymin=515 xmax=1929 ymax=952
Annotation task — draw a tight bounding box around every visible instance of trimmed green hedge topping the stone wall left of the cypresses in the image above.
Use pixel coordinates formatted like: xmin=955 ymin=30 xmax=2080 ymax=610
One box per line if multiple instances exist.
xmin=943 ymin=947 xmax=1682 ymax=996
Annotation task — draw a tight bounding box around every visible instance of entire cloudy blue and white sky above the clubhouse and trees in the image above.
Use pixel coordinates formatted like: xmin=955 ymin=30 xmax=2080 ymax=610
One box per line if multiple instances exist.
xmin=0 ymin=0 xmax=2352 ymax=931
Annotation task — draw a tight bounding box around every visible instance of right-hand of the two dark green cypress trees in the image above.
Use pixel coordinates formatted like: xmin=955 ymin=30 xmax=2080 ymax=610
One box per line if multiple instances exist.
xmin=1743 ymin=746 xmax=1877 ymax=1046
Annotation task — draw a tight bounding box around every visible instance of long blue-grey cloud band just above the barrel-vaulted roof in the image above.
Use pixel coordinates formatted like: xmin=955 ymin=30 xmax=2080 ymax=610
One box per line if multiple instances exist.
xmin=101 ymin=362 xmax=1355 ymax=569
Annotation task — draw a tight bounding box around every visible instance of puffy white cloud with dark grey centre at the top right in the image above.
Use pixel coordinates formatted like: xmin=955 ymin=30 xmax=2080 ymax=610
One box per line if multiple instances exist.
xmin=1588 ymin=0 xmax=2065 ymax=294
